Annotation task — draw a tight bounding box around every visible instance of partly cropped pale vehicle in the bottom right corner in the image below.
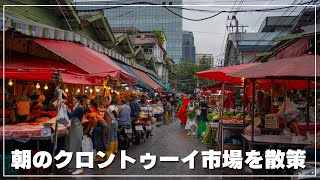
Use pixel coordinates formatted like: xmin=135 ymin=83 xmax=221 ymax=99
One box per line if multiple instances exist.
xmin=291 ymin=161 xmax=320 ymax=180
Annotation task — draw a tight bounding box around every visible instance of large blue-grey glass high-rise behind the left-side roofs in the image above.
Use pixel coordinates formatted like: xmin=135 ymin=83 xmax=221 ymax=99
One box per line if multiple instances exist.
xmin=75 ymin=0 xmax=182 ymax=62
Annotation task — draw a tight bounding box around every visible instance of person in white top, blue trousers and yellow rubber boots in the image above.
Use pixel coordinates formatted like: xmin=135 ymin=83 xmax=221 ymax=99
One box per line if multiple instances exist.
xmin=107 ymin=99 xmax=119 ymax=154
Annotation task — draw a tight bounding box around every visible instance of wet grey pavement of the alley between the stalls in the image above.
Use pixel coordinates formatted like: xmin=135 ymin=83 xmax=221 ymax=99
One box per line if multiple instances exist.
xmin=84 ymin=119 xmax=222 ymax=175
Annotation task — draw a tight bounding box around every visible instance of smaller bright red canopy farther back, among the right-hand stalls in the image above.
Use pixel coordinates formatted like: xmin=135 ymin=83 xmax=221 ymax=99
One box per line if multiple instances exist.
xmin=196 ymin=63 xmax=259 ymax=82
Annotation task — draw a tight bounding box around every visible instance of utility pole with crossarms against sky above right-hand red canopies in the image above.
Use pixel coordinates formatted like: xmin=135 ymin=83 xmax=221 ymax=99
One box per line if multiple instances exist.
xmin=227 ymin=13 xmax=248 ymax=65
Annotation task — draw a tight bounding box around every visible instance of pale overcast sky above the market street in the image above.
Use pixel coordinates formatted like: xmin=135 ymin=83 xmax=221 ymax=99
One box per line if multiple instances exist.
xmin=77 ymin=0 xmax=311 ymax=58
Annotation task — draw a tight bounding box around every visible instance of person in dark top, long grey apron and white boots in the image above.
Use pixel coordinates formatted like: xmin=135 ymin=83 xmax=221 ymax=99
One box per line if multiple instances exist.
xmin=67 ymin=95 xmax=84 ymax=175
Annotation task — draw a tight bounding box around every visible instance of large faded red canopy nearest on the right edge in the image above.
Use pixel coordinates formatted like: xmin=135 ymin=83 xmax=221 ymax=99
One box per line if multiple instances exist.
xmin=227 ymin=55 xmax=320 ymax=78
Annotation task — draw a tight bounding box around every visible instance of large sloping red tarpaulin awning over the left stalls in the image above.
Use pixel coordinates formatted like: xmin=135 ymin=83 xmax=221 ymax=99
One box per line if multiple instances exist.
xmin=35 ymin=39 xmax=137 ymax=82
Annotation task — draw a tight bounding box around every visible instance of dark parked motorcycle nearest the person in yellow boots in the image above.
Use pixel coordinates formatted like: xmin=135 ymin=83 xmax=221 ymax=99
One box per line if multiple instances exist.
xmin=118 ymin=123 xmax=133 ymax=150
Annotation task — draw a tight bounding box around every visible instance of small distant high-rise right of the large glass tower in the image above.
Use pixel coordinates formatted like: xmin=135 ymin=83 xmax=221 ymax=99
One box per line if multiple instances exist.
xmin=182 ymin=31 xmax=196 ymax=63
